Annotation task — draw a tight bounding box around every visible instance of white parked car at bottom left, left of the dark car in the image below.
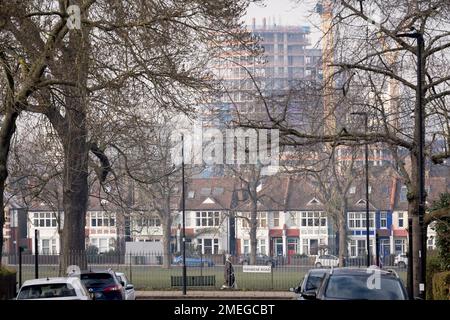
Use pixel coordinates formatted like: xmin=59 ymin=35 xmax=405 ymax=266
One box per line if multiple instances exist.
xmin=16 ymin=277 xmax=91 ymax=300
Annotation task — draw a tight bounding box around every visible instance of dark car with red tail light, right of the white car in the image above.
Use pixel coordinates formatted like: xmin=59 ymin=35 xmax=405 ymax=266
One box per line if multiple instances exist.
xmin=80 ymin=270 xmax=125 ymax=300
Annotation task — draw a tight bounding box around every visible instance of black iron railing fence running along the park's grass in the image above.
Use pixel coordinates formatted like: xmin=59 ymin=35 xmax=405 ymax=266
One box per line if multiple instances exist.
xmin=2 ymin=252 xmax=407 ymax=291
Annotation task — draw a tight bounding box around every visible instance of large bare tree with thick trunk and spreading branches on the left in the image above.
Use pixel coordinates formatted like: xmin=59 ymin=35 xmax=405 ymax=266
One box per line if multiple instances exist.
xmin=1 ymin=0 xmax=256 ymax=269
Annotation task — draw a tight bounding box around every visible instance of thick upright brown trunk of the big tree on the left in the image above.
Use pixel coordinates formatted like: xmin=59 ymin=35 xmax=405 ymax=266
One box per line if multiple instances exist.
xmin=56 ymin=24 xmax=89 ymax=274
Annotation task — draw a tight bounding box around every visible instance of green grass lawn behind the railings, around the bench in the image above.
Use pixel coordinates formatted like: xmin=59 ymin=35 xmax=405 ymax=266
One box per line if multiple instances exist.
xmin=8 ymin=265 xmax=406 ymax=291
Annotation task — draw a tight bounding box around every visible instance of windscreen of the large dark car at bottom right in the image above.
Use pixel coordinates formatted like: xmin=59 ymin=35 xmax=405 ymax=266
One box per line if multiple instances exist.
xmin=325 ymin=274 xmax=405 ymax=300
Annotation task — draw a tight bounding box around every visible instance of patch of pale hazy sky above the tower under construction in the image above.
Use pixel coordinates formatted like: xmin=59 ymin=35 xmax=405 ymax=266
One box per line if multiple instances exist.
xmin=245 ymin=0 xmax=320 ymax=45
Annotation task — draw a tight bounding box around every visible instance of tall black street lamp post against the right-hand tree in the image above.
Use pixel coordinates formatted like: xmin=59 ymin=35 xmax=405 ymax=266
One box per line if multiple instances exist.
xmin=397 ymin=29 xmax=427 ymax=299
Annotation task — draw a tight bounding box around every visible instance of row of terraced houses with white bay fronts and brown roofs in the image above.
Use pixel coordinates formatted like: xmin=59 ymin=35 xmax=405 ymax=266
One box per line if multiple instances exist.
xmin=4 ymin=168 xmax=450 ymax=257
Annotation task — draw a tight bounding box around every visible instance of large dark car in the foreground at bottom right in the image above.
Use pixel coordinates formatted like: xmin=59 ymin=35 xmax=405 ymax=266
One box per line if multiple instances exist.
xmin=308 ymin=268 xmax=408 ymax=300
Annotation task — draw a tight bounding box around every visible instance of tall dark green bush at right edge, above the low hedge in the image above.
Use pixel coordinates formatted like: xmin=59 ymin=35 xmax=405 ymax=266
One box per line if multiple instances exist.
xmin=430 ymin=193 xmax=450 ymax=271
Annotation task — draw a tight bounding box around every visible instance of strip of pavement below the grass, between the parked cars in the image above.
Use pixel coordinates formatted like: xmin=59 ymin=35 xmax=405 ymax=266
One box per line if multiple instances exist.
xmin=136 ymin=289 xmax=295 ymax=300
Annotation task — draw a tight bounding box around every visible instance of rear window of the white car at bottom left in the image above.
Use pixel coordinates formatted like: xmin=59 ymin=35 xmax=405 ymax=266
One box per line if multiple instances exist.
xmin=17 ymin=283 xmax=77 ymax=300
